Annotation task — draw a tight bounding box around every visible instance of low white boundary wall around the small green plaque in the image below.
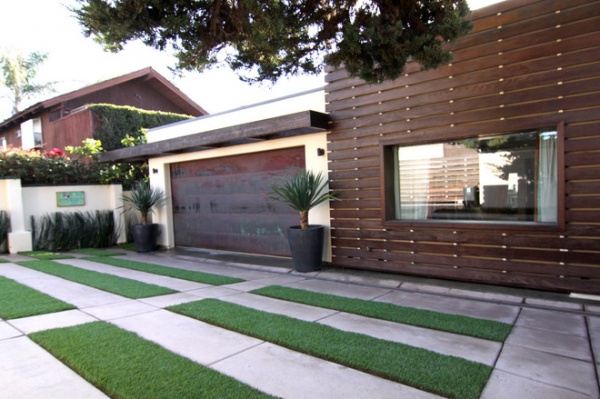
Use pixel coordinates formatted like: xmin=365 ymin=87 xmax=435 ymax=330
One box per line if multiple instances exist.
xmin=0 ymin=179 xmax=126 ymax=254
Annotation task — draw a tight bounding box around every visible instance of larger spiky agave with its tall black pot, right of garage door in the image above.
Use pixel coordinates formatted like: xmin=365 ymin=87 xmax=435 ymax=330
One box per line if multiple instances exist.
xmin=269 ymin=171 xmax=337 ymax=272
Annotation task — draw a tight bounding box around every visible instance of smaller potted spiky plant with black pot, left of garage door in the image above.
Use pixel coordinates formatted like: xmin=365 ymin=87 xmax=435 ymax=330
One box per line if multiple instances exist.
xmin=123 ymin=181 xmax=167 ymax=252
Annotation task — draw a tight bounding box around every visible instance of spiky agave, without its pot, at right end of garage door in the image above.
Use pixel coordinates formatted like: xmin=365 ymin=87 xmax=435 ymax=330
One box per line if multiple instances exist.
xmin=269 ymin=171 xmax=337 ymax=229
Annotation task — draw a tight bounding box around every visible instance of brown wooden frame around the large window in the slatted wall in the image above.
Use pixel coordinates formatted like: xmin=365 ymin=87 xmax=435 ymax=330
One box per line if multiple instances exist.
xmin=379 ymin=122 xmax=565 ymax=232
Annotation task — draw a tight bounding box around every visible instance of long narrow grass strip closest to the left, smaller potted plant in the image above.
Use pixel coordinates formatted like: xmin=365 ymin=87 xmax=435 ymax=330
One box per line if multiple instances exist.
xmin=86 ymin=258 xmax=244 ymax=285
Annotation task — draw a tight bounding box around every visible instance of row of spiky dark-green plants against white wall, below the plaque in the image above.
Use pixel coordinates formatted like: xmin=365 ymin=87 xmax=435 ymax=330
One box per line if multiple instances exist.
xmin=31 ymin=211 xmax=120 ymax=252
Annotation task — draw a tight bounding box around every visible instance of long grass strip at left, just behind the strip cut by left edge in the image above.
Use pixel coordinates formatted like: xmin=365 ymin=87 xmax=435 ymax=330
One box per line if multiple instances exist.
xmin=18 ymin=260 xmax=177 ymax=299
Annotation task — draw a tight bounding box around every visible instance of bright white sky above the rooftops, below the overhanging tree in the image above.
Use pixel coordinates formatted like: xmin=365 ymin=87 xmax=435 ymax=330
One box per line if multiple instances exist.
xmin=0 ymin=0 xmax=502 ymax=121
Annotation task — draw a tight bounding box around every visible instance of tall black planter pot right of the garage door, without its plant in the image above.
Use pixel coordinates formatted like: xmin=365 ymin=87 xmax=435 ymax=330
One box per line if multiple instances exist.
xmin=288 ymin=225 xmax=324 ymax=272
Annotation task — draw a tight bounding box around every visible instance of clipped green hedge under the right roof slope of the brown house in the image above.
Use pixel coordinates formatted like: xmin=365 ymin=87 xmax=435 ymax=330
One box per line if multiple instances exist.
xmin=88 ymin=104 xmax=193 ymax=151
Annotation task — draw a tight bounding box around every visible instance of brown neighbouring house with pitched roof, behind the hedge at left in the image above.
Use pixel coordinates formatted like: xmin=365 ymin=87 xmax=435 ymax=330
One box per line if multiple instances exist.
xmin=0 ymin=68 xmax=207 ymax=150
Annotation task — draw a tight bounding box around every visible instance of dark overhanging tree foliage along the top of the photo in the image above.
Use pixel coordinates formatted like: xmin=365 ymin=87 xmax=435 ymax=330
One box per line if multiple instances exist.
xmin=73 ymin=0 xmax=471 ymax=83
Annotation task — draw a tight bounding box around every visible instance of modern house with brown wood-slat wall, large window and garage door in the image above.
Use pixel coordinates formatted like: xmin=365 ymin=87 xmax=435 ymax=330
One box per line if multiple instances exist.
xmin=106 ymin=0 xmax=600 ymax=295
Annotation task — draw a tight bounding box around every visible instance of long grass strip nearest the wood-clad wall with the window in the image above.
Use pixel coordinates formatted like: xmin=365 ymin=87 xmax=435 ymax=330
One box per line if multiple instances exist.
xmin=251 ymin=285 xmax=512 ymax=342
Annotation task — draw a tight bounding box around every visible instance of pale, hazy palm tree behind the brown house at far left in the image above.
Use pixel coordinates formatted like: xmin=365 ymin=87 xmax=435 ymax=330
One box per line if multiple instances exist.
xmin=0 ymin=50 xmax=53 ymax=114
